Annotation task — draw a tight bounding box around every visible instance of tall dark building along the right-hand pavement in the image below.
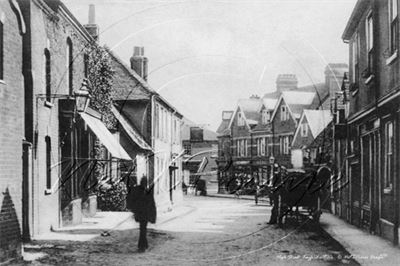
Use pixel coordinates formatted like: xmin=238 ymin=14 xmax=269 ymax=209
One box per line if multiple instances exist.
xmin=334 ymin=0 xmax=400 ymax=244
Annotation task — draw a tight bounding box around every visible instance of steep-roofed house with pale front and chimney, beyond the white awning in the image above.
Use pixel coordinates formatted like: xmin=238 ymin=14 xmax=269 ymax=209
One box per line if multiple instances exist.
xmin=108 ymin=47 xmax=183 ymax=211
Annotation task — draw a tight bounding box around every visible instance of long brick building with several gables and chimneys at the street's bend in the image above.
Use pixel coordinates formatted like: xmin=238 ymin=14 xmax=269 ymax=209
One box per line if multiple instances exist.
xmin=217 ymin=64 xmax=347 ymax=192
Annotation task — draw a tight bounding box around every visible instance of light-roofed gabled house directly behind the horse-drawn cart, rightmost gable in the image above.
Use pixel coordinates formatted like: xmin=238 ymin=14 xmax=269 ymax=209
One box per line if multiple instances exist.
xmin=291 ymin=109 xmax=332 ymax=168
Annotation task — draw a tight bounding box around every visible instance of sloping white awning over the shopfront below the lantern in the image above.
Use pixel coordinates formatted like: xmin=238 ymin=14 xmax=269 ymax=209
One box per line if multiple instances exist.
xmin=80 ymin=113 xmax=132 ymax=160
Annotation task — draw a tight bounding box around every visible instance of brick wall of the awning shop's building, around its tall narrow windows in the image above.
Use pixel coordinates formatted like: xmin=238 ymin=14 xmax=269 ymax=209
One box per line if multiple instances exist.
xmin=21 ymin=1 xmax=92 ymax=235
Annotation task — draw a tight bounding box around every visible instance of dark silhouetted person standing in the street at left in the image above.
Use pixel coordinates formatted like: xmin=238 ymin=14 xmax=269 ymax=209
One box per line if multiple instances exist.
xmin=131 ymin=177 xmax=157 ymax=252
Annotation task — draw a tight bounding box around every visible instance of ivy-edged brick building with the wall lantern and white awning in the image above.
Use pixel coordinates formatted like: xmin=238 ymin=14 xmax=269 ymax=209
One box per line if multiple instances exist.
xmin=20 ymin=0 xmax=130 ymax=237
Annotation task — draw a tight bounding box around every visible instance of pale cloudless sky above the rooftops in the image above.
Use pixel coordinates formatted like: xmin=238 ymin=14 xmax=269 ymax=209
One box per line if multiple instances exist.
xmin=63 ymin=0 xmax=356 ymax=130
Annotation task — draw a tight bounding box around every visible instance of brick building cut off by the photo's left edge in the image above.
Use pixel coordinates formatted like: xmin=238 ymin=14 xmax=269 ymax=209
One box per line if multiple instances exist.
xmin=0 ymin=1 xmax=26 ymax=263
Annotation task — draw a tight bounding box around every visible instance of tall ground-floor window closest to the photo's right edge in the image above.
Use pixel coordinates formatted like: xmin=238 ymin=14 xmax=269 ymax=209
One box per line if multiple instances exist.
xmin=383 ymin=122 xmax=394 ymax=188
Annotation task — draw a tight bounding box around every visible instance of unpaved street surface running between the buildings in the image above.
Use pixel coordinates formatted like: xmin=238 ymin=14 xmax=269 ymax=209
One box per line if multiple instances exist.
xmin=17 ymin=196 xmax=355 ymax=265
